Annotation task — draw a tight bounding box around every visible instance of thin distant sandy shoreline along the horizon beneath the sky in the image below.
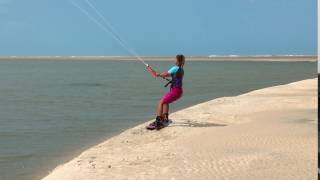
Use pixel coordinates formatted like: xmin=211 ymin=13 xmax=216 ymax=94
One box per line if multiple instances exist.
xmin=0 ymin=55 xmax=318 ymax=62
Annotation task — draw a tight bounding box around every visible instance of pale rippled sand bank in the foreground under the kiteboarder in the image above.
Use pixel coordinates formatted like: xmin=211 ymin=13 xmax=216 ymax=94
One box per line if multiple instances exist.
xmin=44 ymin=79 xmax=317 ymax=180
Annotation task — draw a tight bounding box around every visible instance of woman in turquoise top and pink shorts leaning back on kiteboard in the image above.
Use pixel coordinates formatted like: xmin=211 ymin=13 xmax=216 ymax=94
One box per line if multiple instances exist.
xmin=147 ymin=54 xmax=185 ymax=130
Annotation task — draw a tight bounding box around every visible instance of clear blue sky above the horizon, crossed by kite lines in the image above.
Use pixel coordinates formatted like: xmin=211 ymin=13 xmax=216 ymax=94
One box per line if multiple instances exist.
xmin=0 ymin=0 xmax=317 ymax=56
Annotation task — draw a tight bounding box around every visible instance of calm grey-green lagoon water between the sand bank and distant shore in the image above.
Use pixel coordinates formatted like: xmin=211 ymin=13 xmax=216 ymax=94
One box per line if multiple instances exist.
xmin=0 ymin=60 xmax=316 ymax=180
